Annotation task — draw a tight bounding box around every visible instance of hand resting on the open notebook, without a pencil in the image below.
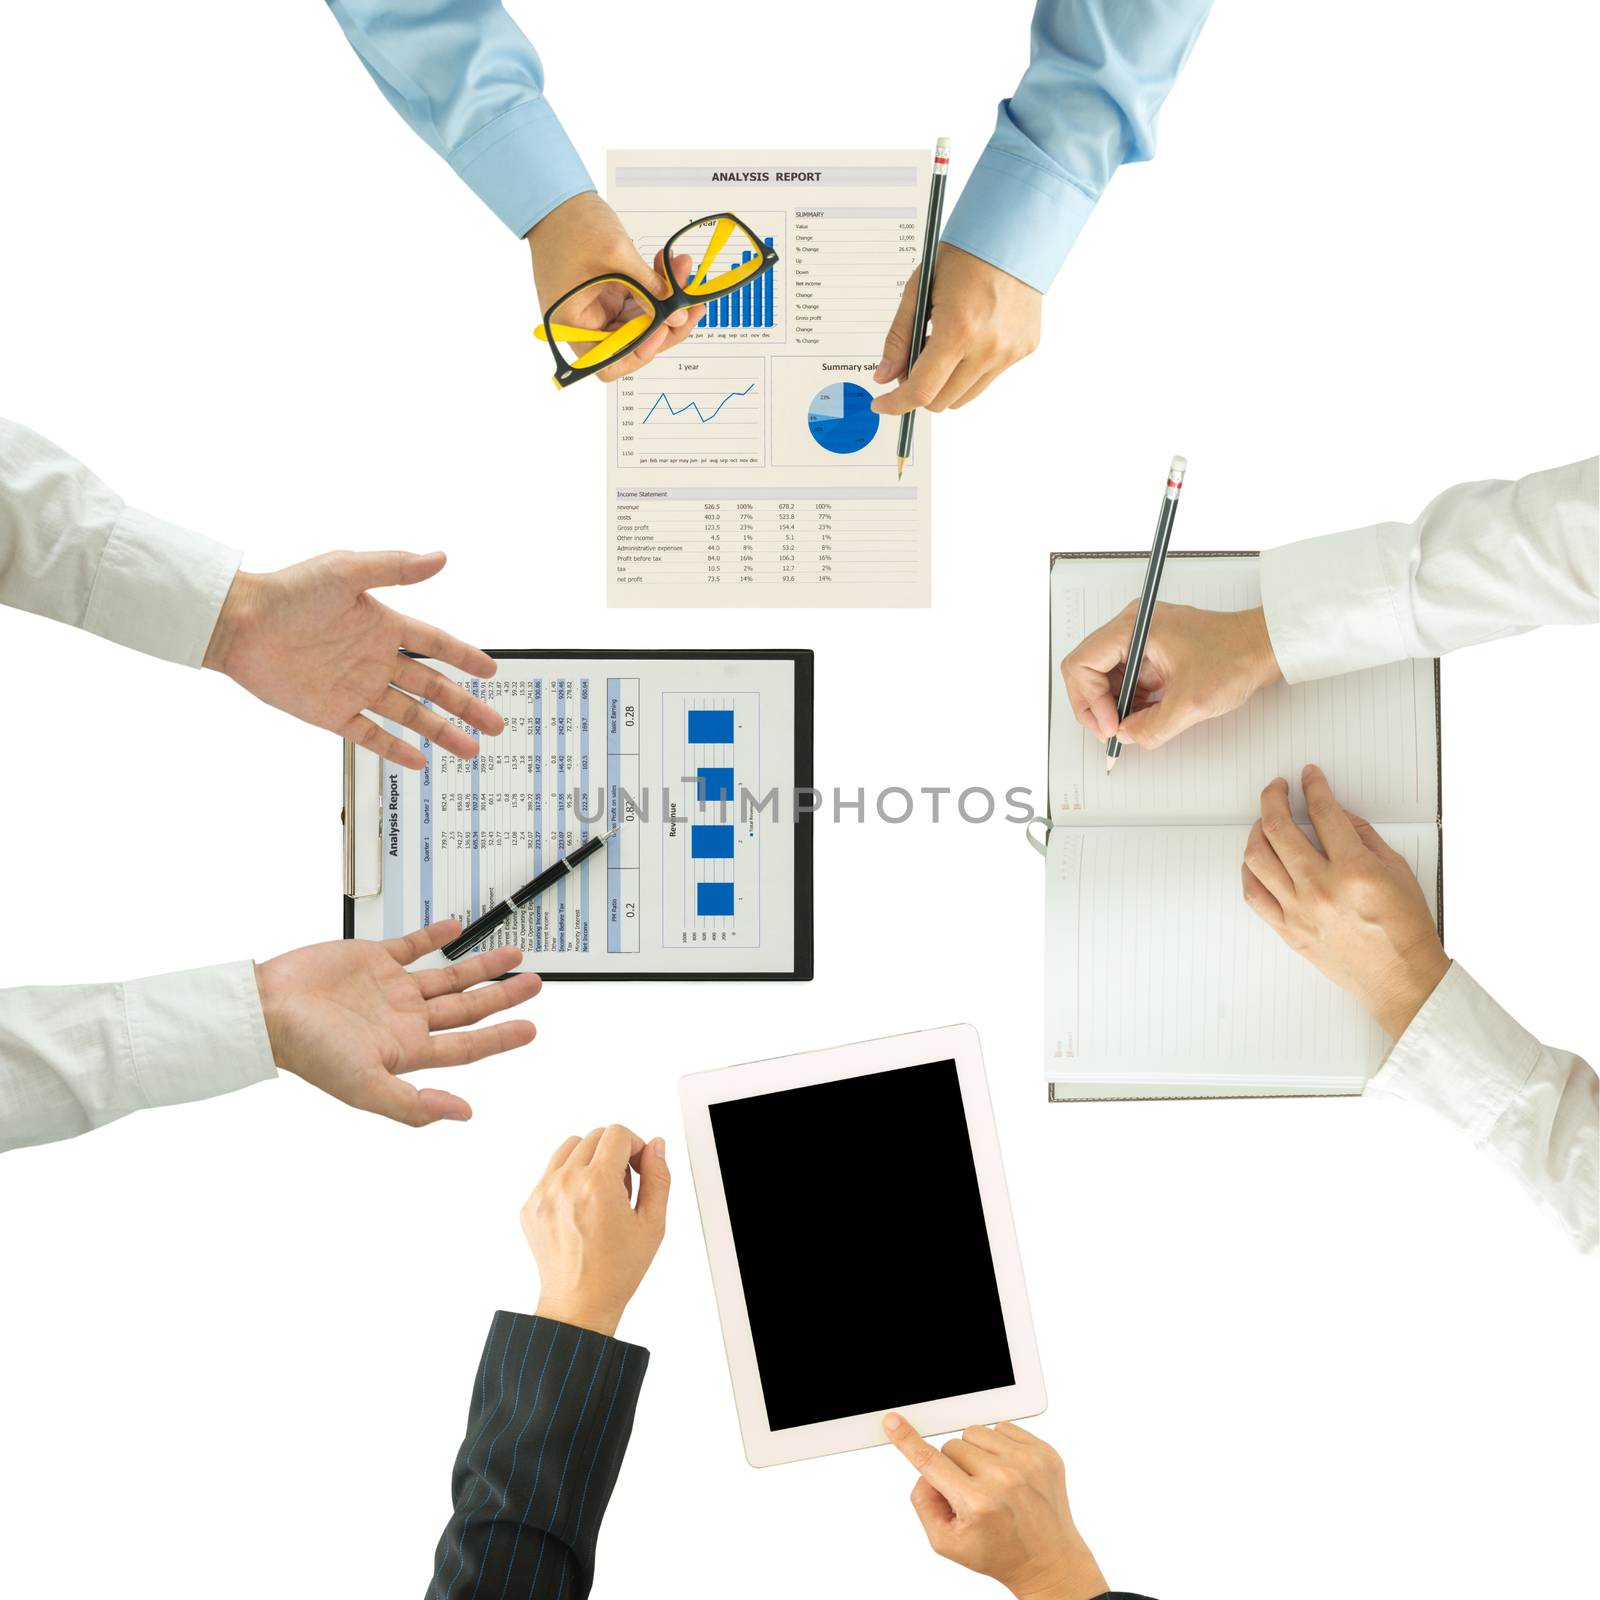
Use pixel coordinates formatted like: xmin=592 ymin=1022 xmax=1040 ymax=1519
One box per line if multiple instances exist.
xmin=1240 ymin=766 xmax=1450 ymax=1038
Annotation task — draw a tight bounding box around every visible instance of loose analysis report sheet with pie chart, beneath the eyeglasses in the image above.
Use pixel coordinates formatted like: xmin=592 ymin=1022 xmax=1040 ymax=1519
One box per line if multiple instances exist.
xmin=606 ymin=150 xmax=933 ymax=606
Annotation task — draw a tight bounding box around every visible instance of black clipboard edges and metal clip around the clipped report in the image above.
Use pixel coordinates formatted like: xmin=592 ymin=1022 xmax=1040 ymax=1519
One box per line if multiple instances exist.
xmin=339 ymin=646 xmax=816 ymax=982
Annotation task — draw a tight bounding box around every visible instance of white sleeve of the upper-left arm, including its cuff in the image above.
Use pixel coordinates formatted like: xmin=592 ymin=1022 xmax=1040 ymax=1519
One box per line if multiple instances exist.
xmin=0 ymin=418 xmax=240 ymax=667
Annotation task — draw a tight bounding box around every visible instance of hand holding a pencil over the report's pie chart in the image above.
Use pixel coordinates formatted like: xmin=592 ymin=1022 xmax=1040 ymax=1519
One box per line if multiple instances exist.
xmin=872 ymin=245 xmax=1045 ymax=416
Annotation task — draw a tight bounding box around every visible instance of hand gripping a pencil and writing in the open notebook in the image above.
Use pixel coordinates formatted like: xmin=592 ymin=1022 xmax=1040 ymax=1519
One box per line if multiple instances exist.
xmin=1061 ymin=600 xmax=1283 ymax=750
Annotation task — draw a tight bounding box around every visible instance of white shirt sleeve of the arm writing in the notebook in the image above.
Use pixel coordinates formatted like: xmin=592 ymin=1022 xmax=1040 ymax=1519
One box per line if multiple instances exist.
xmin=1261 ymin=458 xmax=1600 ymax=683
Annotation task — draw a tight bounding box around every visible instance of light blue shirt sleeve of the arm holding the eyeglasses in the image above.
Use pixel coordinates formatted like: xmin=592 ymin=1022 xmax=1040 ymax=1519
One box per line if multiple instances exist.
xmin=328 ymin=0 xmax=595 ymax=238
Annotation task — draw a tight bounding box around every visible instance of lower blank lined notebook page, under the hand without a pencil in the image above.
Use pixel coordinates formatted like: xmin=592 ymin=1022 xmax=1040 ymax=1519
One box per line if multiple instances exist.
xmin=1045 ymin=822 xmax=1438 ymax=1096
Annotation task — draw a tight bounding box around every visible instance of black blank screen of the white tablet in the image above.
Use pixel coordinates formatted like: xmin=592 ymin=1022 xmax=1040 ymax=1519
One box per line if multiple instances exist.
xmin=710 ymin=1061 xmax=1013 ymax=1430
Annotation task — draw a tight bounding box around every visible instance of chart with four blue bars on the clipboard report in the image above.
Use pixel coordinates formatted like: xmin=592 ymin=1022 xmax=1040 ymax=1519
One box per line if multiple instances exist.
xmin=661 ymin=691 xmax=770 ymax=947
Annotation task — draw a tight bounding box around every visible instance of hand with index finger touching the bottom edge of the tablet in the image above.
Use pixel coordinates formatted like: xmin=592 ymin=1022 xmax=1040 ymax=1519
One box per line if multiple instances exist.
xmin=883 ymin=1411 xmax=1106 ymax=1600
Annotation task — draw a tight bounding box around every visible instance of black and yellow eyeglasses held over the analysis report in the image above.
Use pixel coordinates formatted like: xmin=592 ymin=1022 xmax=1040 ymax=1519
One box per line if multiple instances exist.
xmin=536 ymin=211 xmax=778 ymax=389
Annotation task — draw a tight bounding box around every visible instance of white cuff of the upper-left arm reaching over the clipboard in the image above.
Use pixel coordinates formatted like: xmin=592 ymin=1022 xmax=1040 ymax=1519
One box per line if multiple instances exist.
xmin=83 ymin=506 xmax=240 ymax=667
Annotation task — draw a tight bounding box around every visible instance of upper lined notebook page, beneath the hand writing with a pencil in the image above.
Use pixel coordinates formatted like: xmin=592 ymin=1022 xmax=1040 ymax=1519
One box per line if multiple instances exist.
xmin=1050 ymin=555 xmax=1438 ymax=822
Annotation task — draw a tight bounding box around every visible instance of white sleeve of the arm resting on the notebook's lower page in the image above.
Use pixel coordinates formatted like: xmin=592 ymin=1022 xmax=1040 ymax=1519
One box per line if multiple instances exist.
xmin=1366 ymin=962 xmax=1600 ymax=1250
